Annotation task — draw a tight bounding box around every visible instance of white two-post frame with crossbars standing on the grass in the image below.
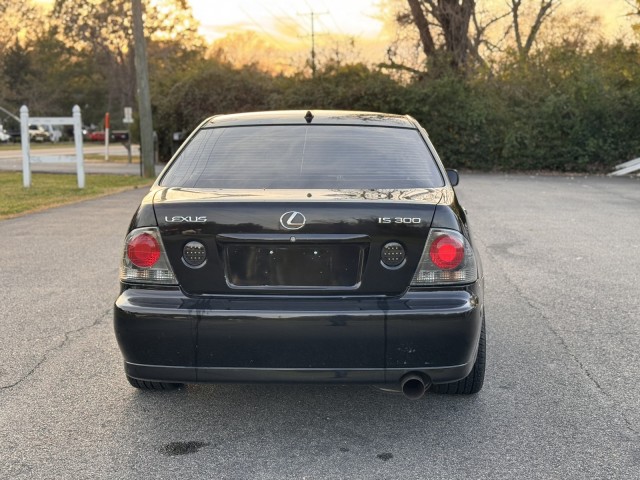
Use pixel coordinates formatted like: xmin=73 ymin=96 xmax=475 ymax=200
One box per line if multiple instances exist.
xmin=20 ymin=105 xmax=84 ymax=188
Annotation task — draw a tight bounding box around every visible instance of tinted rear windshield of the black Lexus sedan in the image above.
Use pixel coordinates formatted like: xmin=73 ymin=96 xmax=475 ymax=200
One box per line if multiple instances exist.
xmin=160 ymin=125 xmax=444 ymax=189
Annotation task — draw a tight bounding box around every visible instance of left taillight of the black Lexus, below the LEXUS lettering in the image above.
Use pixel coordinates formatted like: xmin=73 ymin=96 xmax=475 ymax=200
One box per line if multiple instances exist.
xmin=120 ymin=227 xmax=178 ymax=285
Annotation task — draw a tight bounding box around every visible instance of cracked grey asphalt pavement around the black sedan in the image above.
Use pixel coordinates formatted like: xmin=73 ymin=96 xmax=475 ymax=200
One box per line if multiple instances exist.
xmin=0 ymin=174 xmax=640 ymax=479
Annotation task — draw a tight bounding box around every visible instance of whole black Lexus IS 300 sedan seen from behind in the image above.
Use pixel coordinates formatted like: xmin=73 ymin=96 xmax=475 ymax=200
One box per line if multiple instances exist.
xmin=114 ymin=110 xmax=485 ymax=398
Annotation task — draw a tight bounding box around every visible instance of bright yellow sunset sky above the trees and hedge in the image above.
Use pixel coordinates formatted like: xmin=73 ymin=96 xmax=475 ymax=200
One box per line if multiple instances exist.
xmin=27 ymin=0 xmax=638 ymax=72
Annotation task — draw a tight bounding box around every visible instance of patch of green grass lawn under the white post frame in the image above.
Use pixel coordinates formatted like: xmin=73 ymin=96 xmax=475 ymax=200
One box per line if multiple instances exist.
xmin=0 ymin=172 xmax=152 ymax=220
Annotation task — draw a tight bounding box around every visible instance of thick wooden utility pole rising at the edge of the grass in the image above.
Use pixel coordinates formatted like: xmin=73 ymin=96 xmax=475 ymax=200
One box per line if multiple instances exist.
xmin=132 ymin=0 xmax=156 ymax=178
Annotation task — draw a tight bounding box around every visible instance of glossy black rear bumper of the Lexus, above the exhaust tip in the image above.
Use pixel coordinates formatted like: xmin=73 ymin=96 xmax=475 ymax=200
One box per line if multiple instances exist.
xmin=114 ymin=281 xmax=483 ymax=384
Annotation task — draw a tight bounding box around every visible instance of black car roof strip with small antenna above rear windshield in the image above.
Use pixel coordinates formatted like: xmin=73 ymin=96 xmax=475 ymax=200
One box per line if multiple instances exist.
xmin=202 ymin=110 xmax=416 ymax=128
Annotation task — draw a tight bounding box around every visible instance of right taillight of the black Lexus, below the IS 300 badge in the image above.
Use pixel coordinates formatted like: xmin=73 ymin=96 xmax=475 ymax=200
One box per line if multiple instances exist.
xmin=411 ymin=228 xmax=478 ymax=287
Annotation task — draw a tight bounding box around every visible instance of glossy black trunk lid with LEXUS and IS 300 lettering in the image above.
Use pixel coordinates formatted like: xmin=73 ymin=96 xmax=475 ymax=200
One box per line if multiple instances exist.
xmin=153 ymin=188 xmax=443 ymax=295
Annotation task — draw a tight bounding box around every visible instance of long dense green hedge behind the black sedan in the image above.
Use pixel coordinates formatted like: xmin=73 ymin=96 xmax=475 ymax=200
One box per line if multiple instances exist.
xmin=156 ymin=44 xmax=640 ymax=172
